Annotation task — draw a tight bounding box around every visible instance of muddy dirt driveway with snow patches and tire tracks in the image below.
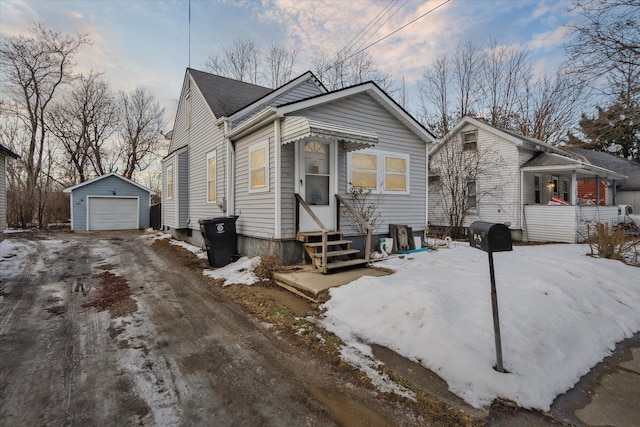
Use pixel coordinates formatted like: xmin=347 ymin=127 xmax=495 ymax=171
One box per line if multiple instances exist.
xmin=0 ymin=233 xmax=432 ymax=426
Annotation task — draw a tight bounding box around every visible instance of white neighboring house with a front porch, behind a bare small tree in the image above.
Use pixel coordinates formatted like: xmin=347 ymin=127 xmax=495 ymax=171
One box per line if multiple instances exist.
xmin=429 ymin=116 xmax=625 ymax=243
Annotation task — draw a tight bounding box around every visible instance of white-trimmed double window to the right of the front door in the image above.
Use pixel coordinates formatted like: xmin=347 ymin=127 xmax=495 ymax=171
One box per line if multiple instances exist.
xmin=348 ymin=150 xmax=409 ymax=194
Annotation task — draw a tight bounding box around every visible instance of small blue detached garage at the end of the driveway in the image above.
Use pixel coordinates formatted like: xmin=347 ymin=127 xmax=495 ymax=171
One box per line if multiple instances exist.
xmin=64 ymin=173 xmax=156 ymax=231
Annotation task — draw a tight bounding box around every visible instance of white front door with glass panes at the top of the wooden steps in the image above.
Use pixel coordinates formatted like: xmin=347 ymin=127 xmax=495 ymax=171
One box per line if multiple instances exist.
xmin=298 ymin=140 xmax=337 ymax=232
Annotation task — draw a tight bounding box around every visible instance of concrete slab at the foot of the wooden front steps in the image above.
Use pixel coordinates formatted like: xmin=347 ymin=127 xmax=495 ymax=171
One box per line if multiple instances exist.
xmin=273 ymin=265 xmax=391 ymax=302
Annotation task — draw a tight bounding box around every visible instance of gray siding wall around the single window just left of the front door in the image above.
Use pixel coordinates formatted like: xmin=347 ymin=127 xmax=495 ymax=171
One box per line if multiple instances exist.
xmin=235 ymin=124 xmax=276 ymax=239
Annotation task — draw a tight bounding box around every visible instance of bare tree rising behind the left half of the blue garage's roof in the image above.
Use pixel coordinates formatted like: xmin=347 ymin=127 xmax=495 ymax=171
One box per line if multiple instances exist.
xmin=48 ymin=72 xmax=119 ymax=183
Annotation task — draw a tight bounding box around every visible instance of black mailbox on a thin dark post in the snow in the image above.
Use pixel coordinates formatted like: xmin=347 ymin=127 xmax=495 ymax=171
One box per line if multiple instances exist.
xmin=469 ymin=221 xmax=513 ymax=372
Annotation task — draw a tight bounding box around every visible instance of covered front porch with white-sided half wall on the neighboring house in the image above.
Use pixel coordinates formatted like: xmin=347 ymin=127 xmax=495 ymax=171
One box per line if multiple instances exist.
xmin=521 ymin=153 xmax=624 ymax=243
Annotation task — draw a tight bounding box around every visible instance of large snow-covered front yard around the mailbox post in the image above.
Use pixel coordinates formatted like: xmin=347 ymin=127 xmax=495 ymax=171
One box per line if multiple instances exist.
xmin=321 ymin=244 xmax=640 ymax=410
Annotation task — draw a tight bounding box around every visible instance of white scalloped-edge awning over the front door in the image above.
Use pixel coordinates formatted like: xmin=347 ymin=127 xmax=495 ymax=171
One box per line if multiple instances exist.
xmin=282 ymin=116 xmax=378 ymax=151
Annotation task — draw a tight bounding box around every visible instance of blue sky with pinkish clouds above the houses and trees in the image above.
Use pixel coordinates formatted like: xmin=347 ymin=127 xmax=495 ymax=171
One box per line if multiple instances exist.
xmin=0 ymin=0 xmax=571 ymax=128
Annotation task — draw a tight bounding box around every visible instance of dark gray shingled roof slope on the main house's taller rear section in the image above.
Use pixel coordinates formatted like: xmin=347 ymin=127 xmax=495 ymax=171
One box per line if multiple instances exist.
xmin=189 ymin=68 xmax=273 ymax=117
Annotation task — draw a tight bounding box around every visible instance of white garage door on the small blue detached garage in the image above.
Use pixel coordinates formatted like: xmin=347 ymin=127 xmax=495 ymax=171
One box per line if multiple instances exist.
xmin=89 ymin=197 xmax=138 ymax=230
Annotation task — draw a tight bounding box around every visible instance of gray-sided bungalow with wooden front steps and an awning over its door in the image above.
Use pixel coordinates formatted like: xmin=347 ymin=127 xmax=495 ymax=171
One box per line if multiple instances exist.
xmin=162 ymin=69 xmax=434 ymax=272
